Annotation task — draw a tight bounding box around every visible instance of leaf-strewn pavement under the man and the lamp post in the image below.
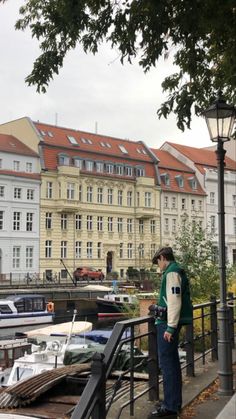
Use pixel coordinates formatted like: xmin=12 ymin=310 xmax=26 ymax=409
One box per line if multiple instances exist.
xmin=107 ymin=350 xmax=236 ymax=419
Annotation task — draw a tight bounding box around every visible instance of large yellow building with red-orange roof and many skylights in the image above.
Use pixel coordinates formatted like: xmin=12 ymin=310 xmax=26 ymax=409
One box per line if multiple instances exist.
xmin=0 ymin=118 xmax=160 ymax=277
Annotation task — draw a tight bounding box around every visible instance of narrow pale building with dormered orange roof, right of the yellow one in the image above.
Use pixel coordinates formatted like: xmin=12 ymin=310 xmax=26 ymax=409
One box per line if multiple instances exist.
xmin=152 ymin=149 xmax=206 ymax=246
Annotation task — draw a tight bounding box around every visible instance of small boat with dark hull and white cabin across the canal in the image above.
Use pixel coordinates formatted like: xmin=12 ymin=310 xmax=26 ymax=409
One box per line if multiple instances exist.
xmin=96 ymin=293 xmax=138 ymax=317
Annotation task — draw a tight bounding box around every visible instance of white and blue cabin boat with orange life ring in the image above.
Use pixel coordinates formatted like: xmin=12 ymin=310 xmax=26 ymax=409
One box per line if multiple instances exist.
xmin=0 ymin=294 xmax=55 ymax=328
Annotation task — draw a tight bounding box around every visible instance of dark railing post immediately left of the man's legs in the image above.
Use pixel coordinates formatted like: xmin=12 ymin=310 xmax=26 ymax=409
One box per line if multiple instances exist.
xmin=148 ymin=317 xmax=159 ymax=401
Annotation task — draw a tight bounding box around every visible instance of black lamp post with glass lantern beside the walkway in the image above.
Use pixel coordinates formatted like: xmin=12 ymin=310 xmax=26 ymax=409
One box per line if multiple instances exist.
xmin=203 ymin=92 xmax=236 ymax=396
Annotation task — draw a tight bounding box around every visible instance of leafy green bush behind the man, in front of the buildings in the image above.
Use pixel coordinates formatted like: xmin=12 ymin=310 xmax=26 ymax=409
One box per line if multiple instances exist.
xmin=173 ymin=217 xmax=219 ymax=301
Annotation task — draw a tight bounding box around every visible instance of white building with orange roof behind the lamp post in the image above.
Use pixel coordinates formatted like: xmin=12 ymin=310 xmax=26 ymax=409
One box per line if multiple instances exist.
xmin=161 ymin=142 xmax=236 ymax=264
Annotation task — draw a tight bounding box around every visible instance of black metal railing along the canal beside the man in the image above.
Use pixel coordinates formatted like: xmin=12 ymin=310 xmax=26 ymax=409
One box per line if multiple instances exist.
xmin=71 ymin=296 xmax=236 ymax=419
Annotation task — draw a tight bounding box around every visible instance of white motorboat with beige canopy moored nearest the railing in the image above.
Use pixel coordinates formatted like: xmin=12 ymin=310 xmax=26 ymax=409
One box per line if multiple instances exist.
xmin=7 ymin=316 xmax=93 ymax=386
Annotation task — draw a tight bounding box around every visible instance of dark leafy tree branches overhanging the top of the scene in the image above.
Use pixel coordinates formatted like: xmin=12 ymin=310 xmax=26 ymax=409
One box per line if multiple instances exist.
xmin=0 ymin=0 xmax=236 ymax=130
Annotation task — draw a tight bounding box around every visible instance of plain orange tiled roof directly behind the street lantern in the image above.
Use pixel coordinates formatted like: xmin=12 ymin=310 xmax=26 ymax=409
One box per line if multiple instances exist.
xmin=167 ymin=142 xmax=236 ymax=170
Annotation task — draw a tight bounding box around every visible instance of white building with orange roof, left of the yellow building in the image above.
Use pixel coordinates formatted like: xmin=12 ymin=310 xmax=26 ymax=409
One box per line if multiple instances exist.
xmin=0 ymin=134 xmax=40 ymax=279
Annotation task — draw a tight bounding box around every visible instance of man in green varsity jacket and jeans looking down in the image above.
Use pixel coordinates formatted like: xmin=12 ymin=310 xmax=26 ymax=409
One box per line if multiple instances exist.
xmin=148 ymin=247 xmax=193 ymax=419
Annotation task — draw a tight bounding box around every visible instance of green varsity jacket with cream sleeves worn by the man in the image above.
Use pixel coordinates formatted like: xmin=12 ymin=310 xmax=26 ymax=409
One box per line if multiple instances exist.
xmin=156 ymin=261 xmax=193 ymax=334
